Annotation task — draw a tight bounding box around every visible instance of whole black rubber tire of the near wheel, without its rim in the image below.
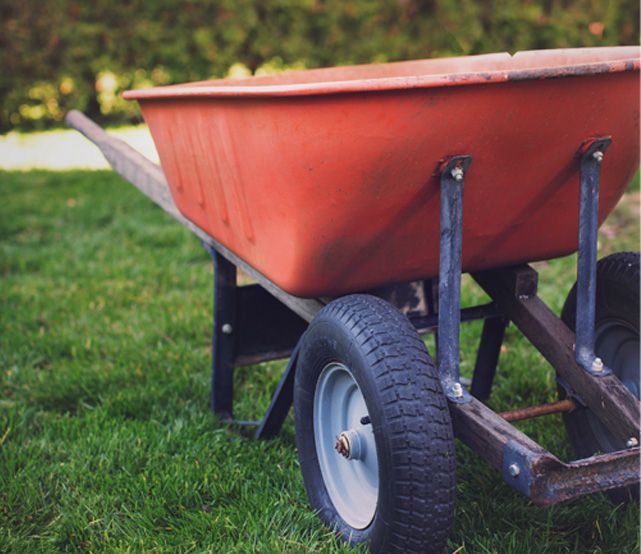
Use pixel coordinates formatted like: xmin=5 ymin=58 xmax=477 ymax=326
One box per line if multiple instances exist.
xmin=294 ymin=295 xmax=456 ymax=553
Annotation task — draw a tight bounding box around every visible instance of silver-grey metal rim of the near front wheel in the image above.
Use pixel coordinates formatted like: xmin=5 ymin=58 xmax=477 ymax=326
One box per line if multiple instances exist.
xmin=314 ymin=362 xmax=378 ymax=529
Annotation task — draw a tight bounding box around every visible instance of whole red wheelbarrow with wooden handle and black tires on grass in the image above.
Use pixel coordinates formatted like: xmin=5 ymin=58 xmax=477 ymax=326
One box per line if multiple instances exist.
xmin=67 ymin=47 xmax=640 ymax=552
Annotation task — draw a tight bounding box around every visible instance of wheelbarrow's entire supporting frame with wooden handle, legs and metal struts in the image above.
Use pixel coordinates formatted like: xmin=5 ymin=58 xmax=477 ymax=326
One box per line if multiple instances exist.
xmin=66 ymin=112 xmax=640 ymax=505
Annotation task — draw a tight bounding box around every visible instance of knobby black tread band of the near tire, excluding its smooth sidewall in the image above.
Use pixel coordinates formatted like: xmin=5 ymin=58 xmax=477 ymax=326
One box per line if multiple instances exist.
xmin=296 ymin=295 xmax=456 ymax=554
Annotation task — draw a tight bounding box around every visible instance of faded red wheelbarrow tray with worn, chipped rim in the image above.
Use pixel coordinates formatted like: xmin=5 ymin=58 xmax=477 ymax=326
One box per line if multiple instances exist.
xmin=125 ymin=47 xmax=640 ymax=297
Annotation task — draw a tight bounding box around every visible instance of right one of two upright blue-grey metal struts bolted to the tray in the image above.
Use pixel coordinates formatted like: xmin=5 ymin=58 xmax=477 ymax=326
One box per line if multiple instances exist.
xmin=576 ymin=137 xmax=612 ymax=375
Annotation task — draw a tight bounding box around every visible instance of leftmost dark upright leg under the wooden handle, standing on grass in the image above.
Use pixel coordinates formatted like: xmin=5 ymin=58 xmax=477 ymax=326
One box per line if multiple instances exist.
xmin=207 ymin=248 xmax=237 ymax=420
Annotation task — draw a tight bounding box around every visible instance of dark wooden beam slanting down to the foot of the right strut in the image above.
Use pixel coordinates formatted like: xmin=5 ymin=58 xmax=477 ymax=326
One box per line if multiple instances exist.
xmin=473 ymin=268 xmax=641 ymax=444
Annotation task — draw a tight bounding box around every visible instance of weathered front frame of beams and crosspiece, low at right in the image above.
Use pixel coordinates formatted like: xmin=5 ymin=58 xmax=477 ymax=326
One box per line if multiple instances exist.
xmin=464 ymin=266 xmax=639 ymax=504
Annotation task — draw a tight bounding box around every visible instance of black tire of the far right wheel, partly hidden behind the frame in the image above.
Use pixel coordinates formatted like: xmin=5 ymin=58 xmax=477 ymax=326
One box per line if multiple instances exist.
xmin=559 ymin=252 xmax=639 ymax=504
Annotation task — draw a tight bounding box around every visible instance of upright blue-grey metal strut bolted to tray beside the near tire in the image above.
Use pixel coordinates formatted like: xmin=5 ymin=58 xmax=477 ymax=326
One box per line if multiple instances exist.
xmin=437 ymin=156 xmax=472 ymax=402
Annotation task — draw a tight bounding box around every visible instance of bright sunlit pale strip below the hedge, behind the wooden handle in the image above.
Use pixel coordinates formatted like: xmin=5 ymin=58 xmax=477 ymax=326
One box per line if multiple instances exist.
xmin=0 ymin=125 xmax=158 ymax=170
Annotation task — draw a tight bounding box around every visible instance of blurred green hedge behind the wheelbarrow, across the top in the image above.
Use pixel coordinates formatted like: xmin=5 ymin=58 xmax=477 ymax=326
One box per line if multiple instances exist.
xmin=0 ymin=0 xmax=639 ymax=132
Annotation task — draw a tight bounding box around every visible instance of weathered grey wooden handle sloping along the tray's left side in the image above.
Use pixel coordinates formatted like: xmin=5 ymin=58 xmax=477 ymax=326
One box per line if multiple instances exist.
xmin=65 ymin=110 xmax=324 ymax=321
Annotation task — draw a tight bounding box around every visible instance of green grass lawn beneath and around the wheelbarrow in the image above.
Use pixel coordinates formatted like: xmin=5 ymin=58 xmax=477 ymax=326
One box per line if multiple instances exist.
xmin=0 ymin=172 xmax=639 ymax=554
